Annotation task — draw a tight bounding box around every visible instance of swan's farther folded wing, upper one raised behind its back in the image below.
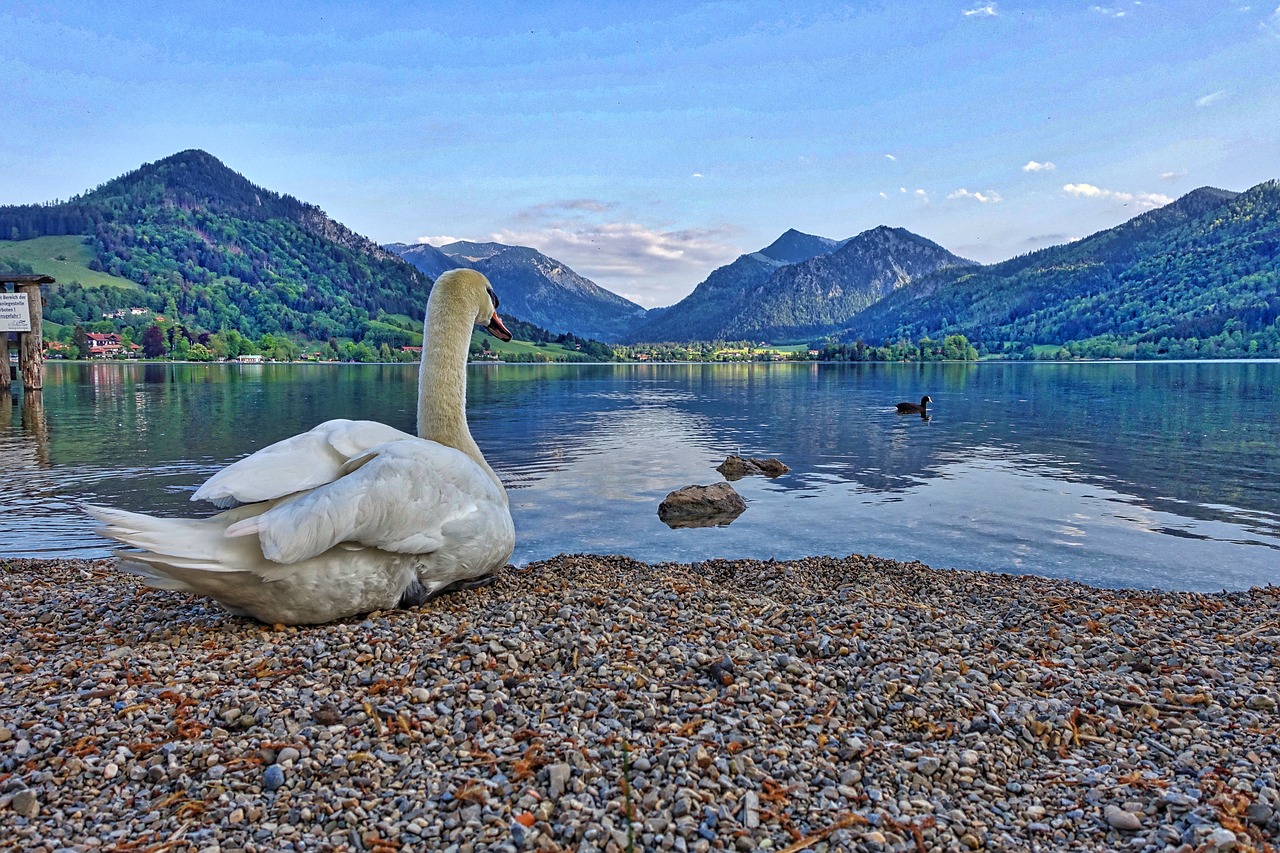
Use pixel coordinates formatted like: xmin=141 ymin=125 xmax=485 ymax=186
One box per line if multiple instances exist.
xmin=191 ymin=419 xmax=415 ymax=507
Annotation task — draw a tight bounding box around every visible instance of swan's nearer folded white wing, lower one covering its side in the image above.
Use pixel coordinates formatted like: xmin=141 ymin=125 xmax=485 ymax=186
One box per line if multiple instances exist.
xmin=227 ymin=439 xmax=506 ymax=564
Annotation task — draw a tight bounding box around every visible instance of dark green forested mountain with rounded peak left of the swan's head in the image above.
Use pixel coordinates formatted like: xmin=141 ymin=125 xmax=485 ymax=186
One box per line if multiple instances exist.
xmin=0 ymin=150 xmax=430 ymax=341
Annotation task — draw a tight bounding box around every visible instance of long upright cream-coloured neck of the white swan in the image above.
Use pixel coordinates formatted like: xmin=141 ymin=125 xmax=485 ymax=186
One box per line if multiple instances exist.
xmin=417 ymin=288 xmax=502 ymax=488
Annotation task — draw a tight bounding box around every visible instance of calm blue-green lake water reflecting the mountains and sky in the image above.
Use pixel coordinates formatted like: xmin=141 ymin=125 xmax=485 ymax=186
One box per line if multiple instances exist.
xmin=0 ymin=362 xmax=1280 ymax=590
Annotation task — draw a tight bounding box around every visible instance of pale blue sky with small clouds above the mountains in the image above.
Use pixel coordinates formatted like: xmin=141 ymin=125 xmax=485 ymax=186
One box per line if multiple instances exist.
xmin=0 ymin=0 xmax=1280 ymax=307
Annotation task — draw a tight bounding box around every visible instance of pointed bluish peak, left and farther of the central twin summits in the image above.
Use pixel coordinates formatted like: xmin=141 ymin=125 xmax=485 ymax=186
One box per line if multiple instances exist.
xmin=627 ymin=228 xmax=841 ymax=341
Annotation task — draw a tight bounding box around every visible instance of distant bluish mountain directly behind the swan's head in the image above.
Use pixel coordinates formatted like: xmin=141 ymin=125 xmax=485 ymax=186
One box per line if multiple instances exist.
xmin=387 ymin=241 xmax=645 ymax=342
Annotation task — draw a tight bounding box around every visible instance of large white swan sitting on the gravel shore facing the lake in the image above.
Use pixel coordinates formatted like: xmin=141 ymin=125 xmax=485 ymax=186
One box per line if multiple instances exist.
xmin=84 ymin=269 xmax=516 ymax=624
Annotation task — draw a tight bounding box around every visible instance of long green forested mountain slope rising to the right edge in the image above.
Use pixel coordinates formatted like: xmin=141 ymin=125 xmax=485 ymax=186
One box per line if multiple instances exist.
xmin=838 ymin=181 xmax=1280 ymax=356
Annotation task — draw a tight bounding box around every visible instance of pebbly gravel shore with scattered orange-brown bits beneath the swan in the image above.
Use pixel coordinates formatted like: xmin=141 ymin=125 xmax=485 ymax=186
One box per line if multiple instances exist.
xmin=0 ymin=556 xmax=1280 ymax=853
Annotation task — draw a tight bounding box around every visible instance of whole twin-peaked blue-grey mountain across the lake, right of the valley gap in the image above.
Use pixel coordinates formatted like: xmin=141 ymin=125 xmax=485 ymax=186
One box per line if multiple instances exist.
xmin=631 ymin=225 xmax=973 ymax=341
